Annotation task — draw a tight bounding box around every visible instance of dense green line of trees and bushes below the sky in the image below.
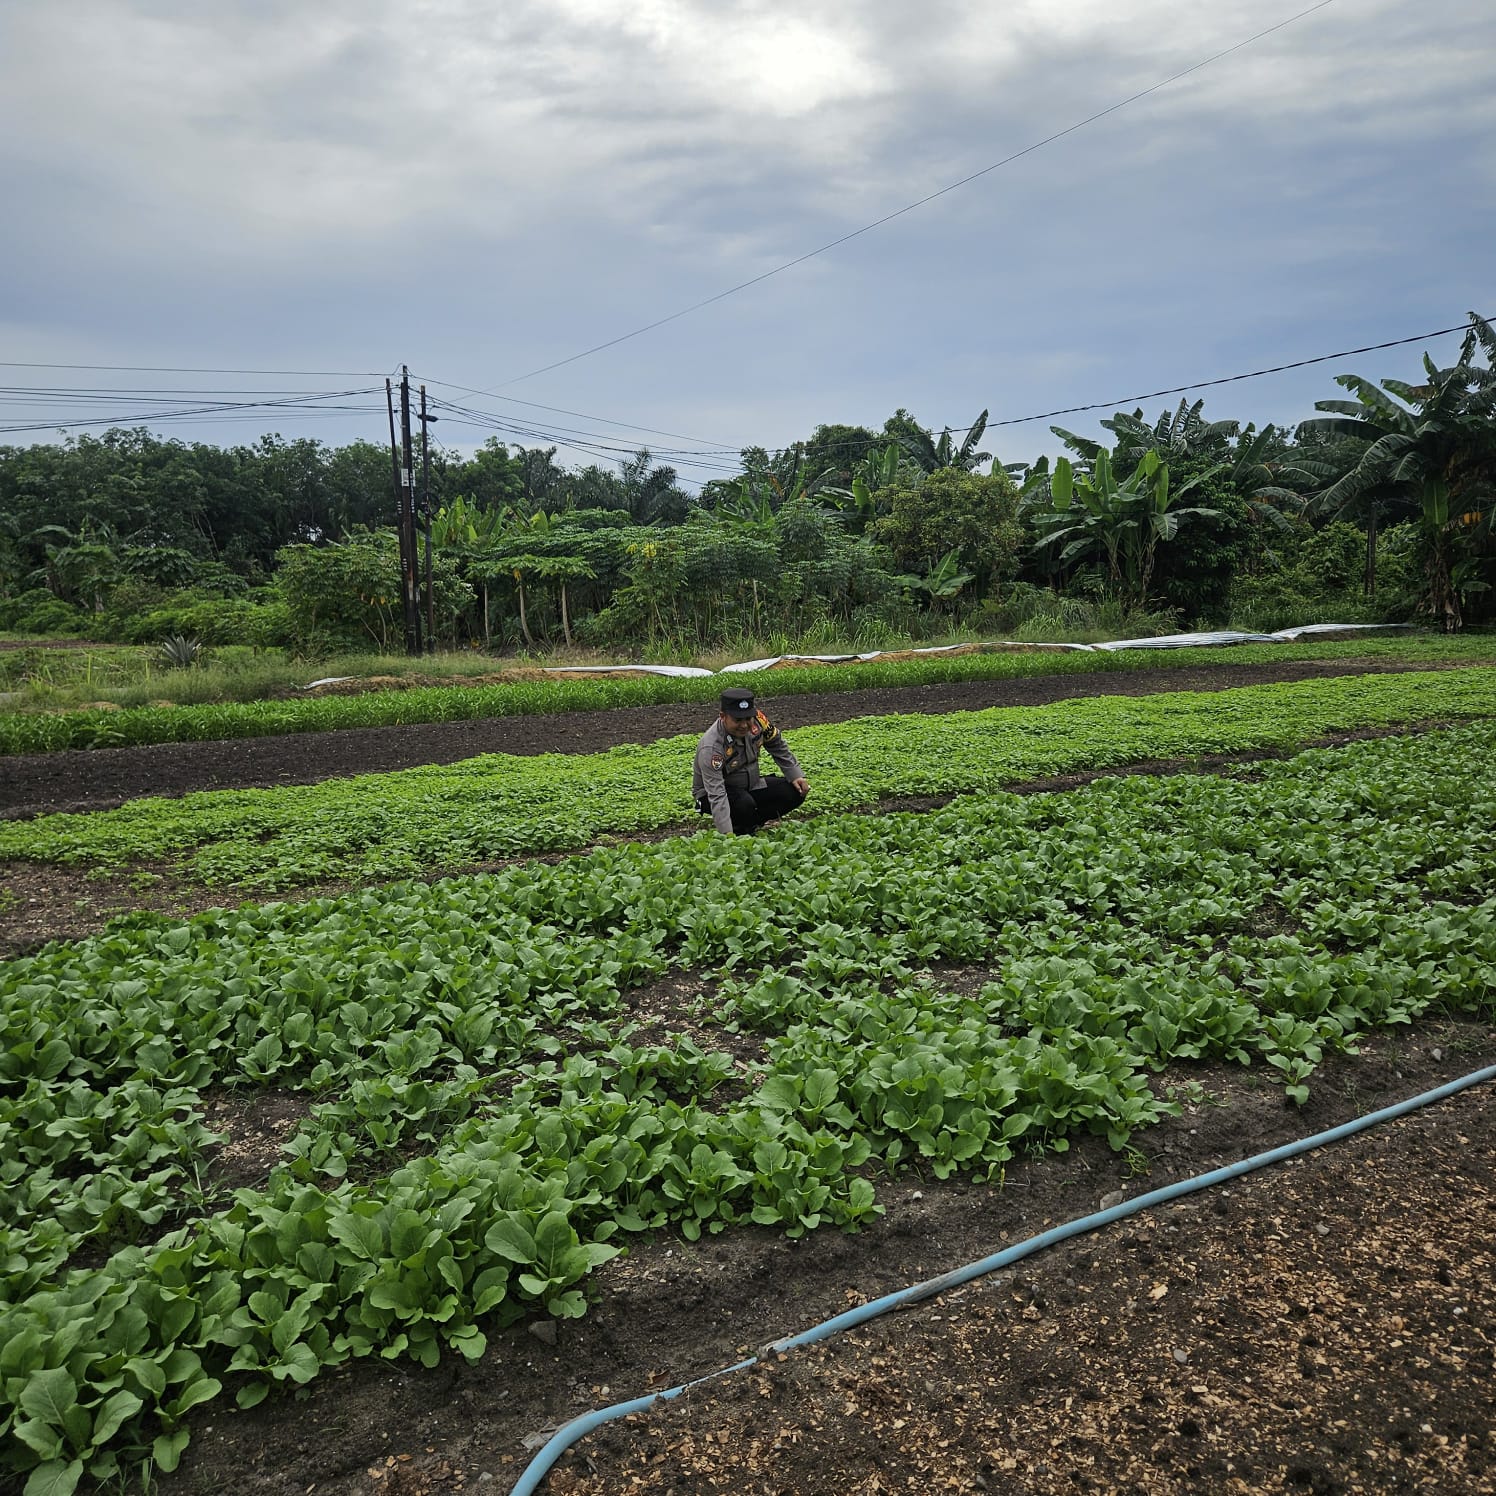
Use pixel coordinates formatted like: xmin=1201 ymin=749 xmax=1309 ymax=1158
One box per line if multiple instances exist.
xmin=0 ymin=314 xmax=1496 ymax=654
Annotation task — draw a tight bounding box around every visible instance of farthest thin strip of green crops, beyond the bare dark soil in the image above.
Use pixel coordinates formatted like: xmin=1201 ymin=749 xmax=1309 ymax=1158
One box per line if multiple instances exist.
xmin=0 ymin=636 xmax=1496 ymax=755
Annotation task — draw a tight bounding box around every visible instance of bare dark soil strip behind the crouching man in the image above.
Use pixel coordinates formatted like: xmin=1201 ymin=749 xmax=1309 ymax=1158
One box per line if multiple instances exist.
xmin=0 ymin=660 xmax=1471 ymax=820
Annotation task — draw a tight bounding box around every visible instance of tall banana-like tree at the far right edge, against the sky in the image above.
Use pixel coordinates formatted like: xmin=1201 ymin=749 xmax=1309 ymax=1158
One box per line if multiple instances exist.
xmin=1300 ymin=311 xmax=1496 ymax=633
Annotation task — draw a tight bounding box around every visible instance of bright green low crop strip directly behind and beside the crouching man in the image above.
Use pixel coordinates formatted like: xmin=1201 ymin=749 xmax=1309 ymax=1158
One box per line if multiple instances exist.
xmin=0 ymin=669 xmax=1496 ymax=889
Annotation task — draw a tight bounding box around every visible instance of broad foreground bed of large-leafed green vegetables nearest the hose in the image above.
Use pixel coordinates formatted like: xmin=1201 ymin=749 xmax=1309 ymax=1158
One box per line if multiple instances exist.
xmin=0 ymin=721 xmax=1496 ymax=1496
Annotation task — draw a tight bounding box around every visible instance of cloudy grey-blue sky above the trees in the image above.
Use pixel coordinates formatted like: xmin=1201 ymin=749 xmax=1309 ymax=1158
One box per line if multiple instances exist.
xmin=0 ymin=0 xmax=1496 ymax=479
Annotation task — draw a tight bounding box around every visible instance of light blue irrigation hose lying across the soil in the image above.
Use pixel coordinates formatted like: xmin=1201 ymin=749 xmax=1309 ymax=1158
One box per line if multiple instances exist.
xmin=510 ymin=1065 xmax=1496 ymax=1496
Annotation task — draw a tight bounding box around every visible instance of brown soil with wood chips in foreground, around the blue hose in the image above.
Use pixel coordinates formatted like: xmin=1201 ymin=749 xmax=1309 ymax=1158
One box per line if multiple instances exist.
xmin=162 ymin=1023 xmax=1496 ymax=1496
